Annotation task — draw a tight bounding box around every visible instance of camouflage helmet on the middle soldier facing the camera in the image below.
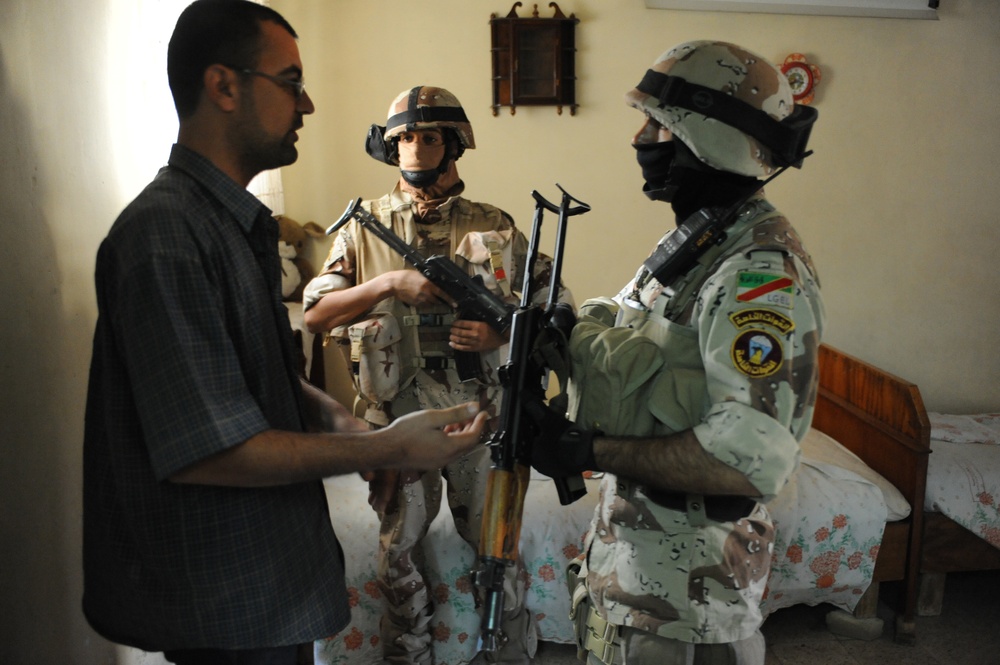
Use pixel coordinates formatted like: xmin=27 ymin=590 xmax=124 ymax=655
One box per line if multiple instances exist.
xmin=385 ymin=85 xmax=476 ymax=148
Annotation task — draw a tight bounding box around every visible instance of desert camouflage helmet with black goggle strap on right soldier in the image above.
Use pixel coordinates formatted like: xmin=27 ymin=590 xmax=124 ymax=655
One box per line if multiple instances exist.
xmin=625 ymin=41 xmax=816 ymax=177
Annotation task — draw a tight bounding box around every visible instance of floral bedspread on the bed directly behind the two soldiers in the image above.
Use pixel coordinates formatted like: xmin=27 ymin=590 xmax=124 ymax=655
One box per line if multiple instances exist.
xmin=315 ymin=434 xmax=886 ymax=665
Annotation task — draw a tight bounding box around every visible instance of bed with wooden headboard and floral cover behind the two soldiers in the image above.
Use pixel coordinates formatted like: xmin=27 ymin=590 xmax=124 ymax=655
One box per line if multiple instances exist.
xmin=315 ymin=346 xmax=929 ymax=665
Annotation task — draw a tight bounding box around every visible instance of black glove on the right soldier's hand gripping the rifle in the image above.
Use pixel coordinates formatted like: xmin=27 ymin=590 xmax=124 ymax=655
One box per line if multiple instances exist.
xmin=524 ymin=398 xmax=602 ymax=478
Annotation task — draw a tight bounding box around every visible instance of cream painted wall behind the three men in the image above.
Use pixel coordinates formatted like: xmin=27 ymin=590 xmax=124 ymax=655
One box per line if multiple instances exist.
xmin=0 ymin=0 xmax=1000 ymax=665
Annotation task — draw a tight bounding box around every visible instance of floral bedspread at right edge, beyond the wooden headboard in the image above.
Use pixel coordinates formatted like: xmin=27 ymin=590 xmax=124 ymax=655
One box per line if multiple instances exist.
xmin=924 ymin=413 xmax=1000 ymax=548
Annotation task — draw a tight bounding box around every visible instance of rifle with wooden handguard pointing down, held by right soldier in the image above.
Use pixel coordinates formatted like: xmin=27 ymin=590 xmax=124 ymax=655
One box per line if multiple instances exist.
xmin=472 ymin=185 xmax=590 ymax=652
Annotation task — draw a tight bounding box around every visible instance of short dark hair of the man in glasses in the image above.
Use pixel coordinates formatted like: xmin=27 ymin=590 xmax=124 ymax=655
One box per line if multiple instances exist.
xmin=167 ymin=0 xmax=298 ymax=119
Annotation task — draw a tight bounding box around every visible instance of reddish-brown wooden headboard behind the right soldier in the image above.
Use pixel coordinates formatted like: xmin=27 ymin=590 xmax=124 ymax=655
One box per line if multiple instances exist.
xmin=812 ymin=344 xmax=931 ymax=641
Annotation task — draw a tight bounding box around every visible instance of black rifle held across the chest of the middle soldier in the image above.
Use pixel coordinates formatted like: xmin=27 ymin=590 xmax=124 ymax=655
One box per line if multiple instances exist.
xmin=326 ymin=198 xmax=514 ymax=381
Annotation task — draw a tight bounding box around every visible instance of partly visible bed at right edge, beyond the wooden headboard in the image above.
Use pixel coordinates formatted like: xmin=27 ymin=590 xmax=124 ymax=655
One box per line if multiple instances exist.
xmin=918 ymin=413 xmax=1000 ymax=616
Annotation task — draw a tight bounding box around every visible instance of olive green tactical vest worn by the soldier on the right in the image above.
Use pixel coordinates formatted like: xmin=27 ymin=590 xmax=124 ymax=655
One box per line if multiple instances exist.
xmin=567 ymin=199 xmax=812 ymax=436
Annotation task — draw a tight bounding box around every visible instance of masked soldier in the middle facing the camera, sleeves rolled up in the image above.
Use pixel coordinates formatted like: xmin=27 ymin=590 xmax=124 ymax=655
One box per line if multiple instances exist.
xmin=304 ymin=86 xmax=569 ymax=663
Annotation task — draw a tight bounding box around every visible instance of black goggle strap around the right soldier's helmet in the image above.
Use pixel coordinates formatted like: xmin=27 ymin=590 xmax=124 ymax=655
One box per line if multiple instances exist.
xmin=636 ymin=69 xmax=819 ymax=168
